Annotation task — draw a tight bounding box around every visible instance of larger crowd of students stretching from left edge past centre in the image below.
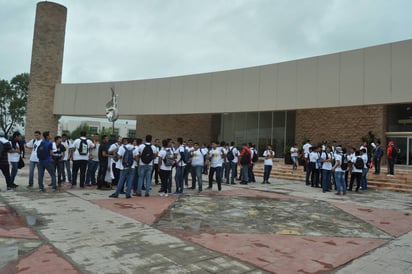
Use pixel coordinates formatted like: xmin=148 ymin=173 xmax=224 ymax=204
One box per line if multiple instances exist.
xmin=2 ymin=131 xmax=275 ymax=198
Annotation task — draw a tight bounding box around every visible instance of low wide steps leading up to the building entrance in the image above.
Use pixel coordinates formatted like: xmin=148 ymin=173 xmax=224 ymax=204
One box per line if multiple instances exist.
xmin=253 ymin=159 xmax=412 ymax=193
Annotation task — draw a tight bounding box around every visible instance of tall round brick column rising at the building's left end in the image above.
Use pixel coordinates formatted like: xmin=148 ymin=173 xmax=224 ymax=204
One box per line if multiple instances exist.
xmin=25 ymin=2 xmax=67 ymax=138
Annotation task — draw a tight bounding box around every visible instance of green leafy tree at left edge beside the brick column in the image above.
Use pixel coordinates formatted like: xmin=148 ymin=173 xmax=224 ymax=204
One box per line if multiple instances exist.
xmin=0 ymin=73 xmax=29 ymax=135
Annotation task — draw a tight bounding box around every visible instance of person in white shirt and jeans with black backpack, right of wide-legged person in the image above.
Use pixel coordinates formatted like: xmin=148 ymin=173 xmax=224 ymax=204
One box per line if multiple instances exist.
xmin=137 ymin=135 xmax=158 ymax=197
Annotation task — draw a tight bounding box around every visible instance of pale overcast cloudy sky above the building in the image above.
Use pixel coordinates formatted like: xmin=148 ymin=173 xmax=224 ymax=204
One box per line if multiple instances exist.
xmin=0 ymin=0 xmax=412 ymax=83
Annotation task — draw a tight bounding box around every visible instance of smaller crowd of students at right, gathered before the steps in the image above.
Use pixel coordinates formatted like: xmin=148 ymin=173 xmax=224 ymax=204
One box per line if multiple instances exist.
xmin=300 ymin=140 xmax=397 ymax=195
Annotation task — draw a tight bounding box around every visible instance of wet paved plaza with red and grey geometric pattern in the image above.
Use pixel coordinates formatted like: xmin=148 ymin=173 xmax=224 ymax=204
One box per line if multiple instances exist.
xmin=0 ymin=170 xmax=412 ymax=274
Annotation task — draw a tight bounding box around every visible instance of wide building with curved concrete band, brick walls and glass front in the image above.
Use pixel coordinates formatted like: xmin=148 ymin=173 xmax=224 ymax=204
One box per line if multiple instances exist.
xmin=29 ymin=1 xmax=412 ymax=165
